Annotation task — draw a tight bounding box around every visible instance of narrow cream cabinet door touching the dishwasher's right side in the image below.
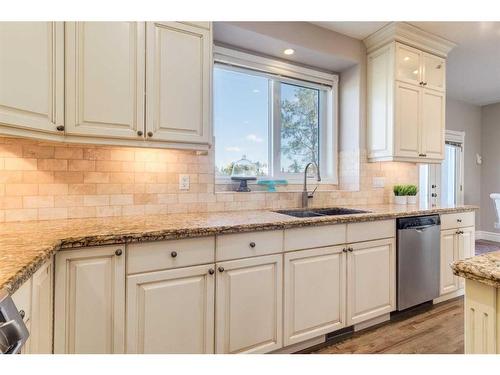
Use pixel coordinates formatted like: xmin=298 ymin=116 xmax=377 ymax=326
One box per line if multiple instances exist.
xmin=440 ymin=229 xmax=458 ymax=295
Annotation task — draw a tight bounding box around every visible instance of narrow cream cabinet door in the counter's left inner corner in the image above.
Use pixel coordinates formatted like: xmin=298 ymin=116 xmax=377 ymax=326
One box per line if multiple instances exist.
xmin=30 ymin=260 xmax=54 ymax=354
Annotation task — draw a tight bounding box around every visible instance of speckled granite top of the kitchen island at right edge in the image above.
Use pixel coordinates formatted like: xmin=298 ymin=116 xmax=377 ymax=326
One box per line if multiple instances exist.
xmin=451 ymin=251 xmax=500 ymax=288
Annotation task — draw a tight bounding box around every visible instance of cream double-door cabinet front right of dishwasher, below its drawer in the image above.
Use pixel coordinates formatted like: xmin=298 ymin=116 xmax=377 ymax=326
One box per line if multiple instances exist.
xmin=439 ymin=227 xmax=475 ymax=296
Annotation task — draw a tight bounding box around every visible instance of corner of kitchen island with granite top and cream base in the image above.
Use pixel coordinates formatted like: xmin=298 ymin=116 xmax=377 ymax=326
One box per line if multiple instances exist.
xmin=451 ymin=251 xmax=500 ymax=354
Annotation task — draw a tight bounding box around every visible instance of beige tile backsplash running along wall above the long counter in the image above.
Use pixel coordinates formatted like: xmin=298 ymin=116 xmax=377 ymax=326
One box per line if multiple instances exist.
xmin=0 ymin=137 xmax=418 ymax=222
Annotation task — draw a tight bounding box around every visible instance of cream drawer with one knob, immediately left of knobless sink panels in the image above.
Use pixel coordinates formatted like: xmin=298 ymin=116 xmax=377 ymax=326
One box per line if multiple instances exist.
xmin=216 ymin=230 xmax=283 ymax=262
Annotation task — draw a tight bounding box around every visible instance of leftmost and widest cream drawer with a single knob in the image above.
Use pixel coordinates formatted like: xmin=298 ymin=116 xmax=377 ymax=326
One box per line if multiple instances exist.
xmin=127 ymin=237 xmax=215 ymax=274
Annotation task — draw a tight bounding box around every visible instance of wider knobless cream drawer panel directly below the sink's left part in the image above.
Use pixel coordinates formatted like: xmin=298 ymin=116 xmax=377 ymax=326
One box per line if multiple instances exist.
xmin=285 ymin=224 xmax=346 ymax=251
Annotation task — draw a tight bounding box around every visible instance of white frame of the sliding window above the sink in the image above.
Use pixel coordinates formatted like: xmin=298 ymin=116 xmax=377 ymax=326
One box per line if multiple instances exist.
xmin=214 ymin=46 xmax=338 ymax=185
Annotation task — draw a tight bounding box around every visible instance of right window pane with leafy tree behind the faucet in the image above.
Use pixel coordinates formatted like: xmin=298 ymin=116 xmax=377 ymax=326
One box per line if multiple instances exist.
xmin=279 ymin=83 xmax=320 ymax=173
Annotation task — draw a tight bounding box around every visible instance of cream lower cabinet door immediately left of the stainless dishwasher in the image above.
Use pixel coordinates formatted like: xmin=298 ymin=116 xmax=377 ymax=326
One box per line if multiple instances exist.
xmin=347 ymin=238 xmax=396 ymax=326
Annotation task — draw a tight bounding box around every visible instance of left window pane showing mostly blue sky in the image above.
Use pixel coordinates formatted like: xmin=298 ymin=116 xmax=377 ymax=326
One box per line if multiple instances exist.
xmin=214 ymin=68 xmax=269 ymax=176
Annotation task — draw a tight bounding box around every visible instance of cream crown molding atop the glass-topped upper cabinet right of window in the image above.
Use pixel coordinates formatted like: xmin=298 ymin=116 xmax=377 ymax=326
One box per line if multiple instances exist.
xmin=363 ymin=22 xmax=456 ymax=57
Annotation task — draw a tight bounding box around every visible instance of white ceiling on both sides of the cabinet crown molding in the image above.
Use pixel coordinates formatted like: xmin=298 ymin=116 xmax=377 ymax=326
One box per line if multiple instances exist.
xmin=315 ymin=22 xmax=500 ymax=105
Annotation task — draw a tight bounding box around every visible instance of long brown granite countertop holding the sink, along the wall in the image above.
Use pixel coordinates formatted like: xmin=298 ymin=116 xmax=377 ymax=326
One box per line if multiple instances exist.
xmin=0 ymin=205 xmax=477 ymax=294
